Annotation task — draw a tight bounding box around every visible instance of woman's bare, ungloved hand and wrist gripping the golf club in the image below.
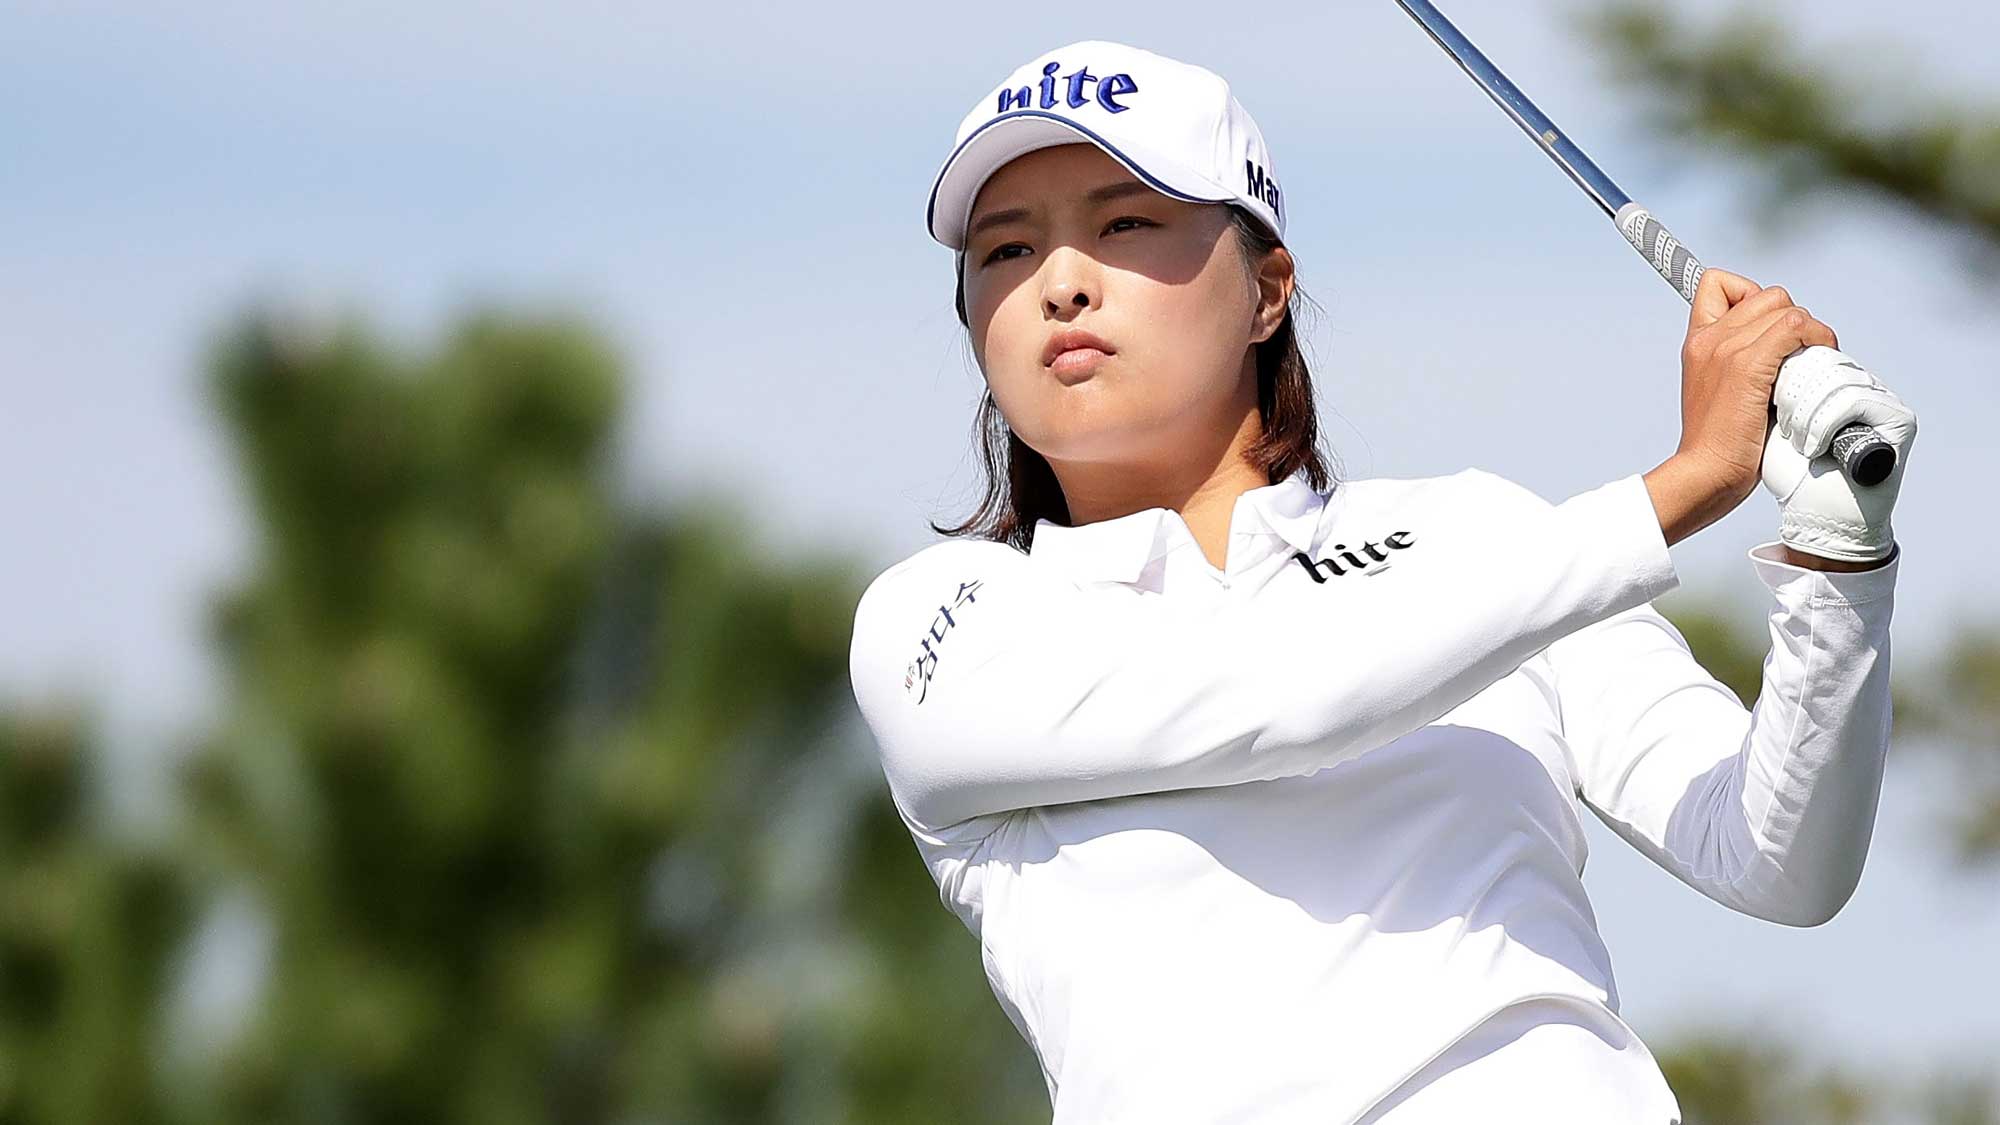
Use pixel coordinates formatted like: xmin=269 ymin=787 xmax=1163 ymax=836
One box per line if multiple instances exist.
xmin=1646 ymin=268 xmax=1840 ymax=544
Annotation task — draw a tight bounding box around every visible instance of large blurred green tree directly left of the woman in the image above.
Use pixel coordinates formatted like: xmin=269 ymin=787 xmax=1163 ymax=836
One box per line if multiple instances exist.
xmin=168 ymin=312 xmax=1046 ymax=1125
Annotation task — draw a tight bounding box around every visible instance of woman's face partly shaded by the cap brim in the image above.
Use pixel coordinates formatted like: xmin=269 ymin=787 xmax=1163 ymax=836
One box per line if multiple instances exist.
xmin=964 ymin=142 xmax=1290 ymax=462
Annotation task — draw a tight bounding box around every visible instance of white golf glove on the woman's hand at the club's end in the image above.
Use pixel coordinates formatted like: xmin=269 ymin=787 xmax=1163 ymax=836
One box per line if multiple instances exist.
xmin=1762 ymin=344 xmax=1916 ymax=563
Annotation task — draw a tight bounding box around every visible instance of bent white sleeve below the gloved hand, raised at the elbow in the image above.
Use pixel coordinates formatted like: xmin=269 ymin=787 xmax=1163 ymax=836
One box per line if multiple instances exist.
xmin=1548 ymin=542 xmax=1902 ymax=927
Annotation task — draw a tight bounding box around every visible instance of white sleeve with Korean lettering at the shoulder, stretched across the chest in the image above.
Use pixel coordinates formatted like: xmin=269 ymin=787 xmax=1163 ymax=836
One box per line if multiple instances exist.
xmin=850 ymin=468 xmax=1678 ymax=829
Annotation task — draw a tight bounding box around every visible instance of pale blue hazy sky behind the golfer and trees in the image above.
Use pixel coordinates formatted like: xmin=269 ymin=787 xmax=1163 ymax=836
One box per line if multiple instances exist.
xmin=0 ymin=0 xmax=2000 ymax=1063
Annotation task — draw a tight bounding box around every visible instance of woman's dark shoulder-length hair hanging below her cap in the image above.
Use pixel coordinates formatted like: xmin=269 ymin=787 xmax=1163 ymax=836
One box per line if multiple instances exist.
xmin=930 ymin=204 xmax=1340 ymax=550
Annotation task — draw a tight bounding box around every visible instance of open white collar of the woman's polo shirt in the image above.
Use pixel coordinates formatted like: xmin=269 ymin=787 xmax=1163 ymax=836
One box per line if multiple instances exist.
xmin=1028 ymin=468 xmax=1328 ymax=583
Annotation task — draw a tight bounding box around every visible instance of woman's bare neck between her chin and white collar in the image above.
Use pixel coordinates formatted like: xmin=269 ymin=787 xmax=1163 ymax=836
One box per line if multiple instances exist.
xmin=1050 ymin=402 xmax=1270 ymax=571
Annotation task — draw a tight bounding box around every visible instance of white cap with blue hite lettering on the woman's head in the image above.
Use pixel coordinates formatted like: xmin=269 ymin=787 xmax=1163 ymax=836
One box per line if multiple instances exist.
xmin=926 ymin=40 xmax=1284 ymax=250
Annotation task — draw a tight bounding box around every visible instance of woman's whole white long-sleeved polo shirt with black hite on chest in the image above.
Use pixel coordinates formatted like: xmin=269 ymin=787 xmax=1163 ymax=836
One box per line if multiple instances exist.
xmin=850 ymin=460 xmax=1898 ymax=1125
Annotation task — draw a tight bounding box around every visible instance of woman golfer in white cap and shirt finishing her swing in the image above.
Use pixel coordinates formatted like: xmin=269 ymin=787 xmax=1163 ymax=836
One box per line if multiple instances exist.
xmin=850 ymin=40 xmax=1916 ymax=1125
